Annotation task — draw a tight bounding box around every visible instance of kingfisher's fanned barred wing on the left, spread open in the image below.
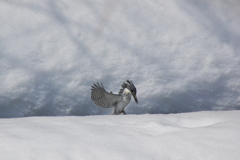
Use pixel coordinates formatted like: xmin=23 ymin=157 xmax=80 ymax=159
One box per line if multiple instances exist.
xmin=91 ymin=83 xmax=122 ymax=108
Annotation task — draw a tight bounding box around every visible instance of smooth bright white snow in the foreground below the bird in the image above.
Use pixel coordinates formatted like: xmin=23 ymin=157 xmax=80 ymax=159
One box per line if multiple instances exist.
xmin=0 ymin=111 xmax=240 ymax=160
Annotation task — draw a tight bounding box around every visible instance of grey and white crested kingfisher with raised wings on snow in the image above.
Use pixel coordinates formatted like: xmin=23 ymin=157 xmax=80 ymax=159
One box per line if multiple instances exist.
xmin=91 ymin=80 xmax=138 ymax=115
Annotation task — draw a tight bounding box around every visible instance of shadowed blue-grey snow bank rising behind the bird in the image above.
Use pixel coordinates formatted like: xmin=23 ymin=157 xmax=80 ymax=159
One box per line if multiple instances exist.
xmin=0 ymin=0 xmax=240 ymax=117
